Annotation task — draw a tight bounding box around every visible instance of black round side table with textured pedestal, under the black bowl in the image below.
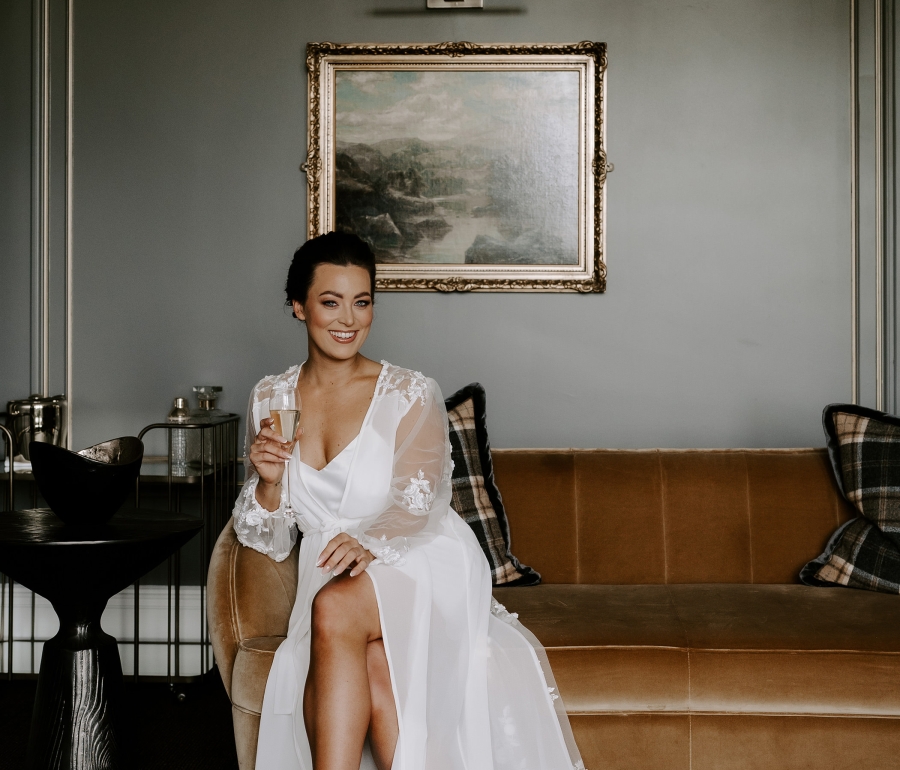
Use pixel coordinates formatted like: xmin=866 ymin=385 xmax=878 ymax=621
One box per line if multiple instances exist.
xmin=0 ymin=510 xmax=203 ymax=770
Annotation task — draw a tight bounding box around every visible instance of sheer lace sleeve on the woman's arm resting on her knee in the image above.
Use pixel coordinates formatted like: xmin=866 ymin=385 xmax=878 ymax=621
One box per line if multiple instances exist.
xmin=357 ymin=373 xmax=453 ymax=565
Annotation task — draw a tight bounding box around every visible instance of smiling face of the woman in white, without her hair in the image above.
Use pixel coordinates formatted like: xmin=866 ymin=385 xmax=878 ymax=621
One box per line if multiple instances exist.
xmin=293 ymin=264 xmax=373 ymax=360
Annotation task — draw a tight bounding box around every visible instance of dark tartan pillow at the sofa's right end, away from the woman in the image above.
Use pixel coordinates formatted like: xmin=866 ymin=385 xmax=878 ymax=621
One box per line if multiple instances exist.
xmin=800 ymin=404 xmax=900 ymax=594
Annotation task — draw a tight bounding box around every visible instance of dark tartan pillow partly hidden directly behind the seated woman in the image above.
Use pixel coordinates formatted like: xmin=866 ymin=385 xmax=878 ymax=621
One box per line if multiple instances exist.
xmin=444 ymin=382 xmax=541 ymax=586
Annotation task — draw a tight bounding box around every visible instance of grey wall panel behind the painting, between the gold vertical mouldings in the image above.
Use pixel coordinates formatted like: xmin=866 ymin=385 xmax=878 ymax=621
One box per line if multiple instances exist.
xmin=7 ymin=0 xmax=850 ymax=447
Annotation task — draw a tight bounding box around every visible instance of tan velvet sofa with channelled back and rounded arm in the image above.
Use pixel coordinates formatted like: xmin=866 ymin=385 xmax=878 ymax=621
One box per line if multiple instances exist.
xmin=209 ymin=449 xmax=900 ymax=770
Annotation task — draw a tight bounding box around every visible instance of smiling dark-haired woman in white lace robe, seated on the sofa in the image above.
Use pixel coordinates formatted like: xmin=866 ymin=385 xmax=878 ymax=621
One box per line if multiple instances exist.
xmin=234 ymin=233 xmax=583 ymax=770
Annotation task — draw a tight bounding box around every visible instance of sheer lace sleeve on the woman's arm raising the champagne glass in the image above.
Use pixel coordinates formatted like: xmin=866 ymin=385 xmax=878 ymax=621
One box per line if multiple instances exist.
xmin=232 ymin=367 xmax=299 ymax=561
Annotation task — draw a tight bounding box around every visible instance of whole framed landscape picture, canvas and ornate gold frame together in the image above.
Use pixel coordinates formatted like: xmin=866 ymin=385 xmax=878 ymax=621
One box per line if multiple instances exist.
xmin=301 ymin=42 xmax=607 ymax=293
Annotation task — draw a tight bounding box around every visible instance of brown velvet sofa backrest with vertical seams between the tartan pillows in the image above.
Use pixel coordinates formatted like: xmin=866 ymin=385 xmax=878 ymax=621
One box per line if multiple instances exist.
xmin=493 ymin=449 xmax=855 ymax=585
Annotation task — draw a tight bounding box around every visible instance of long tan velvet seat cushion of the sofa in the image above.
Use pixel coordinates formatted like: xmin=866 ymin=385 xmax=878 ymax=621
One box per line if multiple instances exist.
xmin=494 ymin=584 xmax=900 ymax=716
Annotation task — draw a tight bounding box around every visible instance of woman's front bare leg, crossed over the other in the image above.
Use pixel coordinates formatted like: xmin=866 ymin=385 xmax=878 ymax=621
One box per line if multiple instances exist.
xmin=303 ymin=573 xmax=396 ymax=770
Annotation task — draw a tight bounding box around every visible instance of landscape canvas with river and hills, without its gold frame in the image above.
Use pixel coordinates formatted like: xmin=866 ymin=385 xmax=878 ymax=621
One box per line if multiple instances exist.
xmin=335 ymin=70 xmax=579 ymax=265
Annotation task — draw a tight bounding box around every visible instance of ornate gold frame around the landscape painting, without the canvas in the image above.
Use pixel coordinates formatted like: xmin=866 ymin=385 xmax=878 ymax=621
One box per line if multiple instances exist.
xmin=301 ymin=42 xmax=607 ymax=293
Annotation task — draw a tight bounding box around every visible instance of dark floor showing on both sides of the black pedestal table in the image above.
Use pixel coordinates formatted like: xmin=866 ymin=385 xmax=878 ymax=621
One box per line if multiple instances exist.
xmin=0 ymin=671 xmax=238 ymax=770
